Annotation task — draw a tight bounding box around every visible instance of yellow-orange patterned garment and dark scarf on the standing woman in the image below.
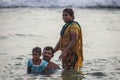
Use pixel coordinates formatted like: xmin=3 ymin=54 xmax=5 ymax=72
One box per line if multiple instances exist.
xmin=60 ymin=21 xmax=83 ymax=70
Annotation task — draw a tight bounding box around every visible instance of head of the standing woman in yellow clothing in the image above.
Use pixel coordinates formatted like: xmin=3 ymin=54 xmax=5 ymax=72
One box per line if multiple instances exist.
xmin=63 ymin=8 xmax=75 ymax=22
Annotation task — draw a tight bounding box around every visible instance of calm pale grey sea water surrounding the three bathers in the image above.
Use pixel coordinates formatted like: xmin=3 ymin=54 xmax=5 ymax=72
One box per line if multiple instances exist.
xmin=0 ymin=0 xmax=120 ymax=80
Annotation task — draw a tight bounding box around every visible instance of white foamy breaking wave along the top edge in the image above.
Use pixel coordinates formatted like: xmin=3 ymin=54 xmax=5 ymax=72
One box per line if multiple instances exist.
xmin=0 ymin=0 xmax=120 ymax=8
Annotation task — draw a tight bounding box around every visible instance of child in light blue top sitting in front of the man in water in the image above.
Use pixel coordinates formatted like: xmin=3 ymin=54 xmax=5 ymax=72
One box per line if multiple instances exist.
xmin=27 ymin=47 xmax=48 ymax=74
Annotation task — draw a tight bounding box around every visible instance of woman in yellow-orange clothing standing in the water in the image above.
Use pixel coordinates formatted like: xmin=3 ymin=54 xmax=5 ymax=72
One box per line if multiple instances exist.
xmin=54 ymin=8 xmax=83 ymax=70
